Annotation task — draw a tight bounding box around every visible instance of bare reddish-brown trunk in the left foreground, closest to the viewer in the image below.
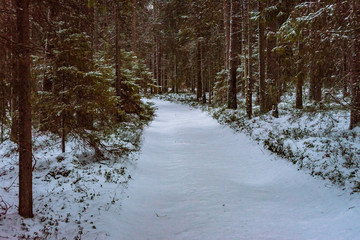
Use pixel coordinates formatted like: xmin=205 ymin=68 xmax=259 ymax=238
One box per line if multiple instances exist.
xmin=16 ymin=0 xmax=33 ymax=218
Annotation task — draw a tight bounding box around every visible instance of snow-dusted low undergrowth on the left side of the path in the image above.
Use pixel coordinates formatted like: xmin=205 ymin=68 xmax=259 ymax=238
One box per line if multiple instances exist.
xmin=0 ymin=105 xmax=154 ymax=239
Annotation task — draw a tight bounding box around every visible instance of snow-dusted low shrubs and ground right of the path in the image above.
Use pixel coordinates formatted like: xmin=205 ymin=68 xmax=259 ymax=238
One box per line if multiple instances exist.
xmin=156 ymin=93 xmax=360 ymax=193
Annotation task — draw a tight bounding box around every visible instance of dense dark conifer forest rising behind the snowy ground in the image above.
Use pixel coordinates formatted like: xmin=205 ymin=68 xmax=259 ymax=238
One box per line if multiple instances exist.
xmin=0 ymin=0 xmax=360 ymax=220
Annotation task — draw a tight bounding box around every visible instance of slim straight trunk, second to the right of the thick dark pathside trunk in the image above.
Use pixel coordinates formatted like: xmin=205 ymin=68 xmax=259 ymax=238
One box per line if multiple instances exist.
xmin=258 ymin=1 xmax=266 ymax=113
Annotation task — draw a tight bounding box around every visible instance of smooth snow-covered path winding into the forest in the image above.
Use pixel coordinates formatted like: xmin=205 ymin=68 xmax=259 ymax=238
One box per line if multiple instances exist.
xmin=104 ymin=100 xmax=360 ymax=240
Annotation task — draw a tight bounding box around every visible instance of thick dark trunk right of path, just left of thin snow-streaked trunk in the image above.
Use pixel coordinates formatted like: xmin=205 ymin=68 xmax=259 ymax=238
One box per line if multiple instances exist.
xmin=228 ymin=0 xmax=241 ymax=109
